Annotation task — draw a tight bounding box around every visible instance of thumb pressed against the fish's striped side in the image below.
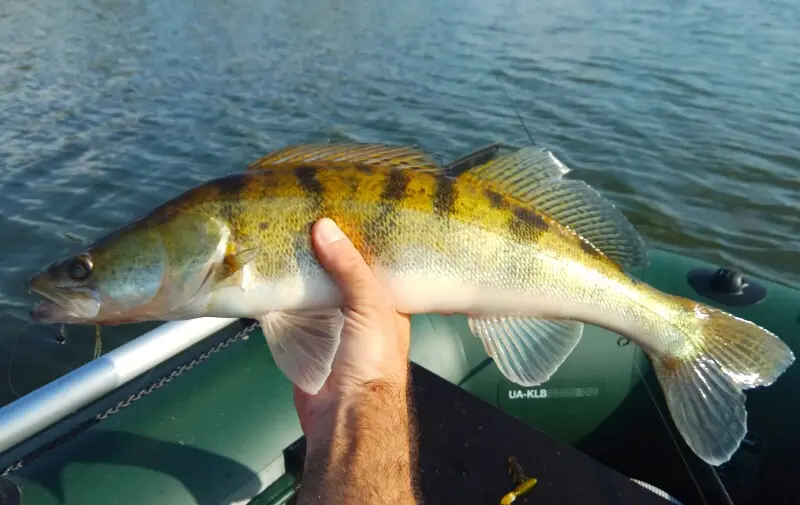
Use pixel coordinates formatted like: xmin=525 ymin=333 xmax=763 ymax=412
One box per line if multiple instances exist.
xmin=311 ymin=218 xmax=383 ymax=304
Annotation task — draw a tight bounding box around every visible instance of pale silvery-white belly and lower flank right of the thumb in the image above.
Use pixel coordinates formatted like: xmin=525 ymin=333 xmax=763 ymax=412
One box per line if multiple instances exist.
xmin=383 ymin=218 xmax=685 ymax=353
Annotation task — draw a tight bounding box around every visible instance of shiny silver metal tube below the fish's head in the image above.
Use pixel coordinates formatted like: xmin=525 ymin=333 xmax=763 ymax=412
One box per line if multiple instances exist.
xmin=0 ymin=317 xmax=237 ymax=452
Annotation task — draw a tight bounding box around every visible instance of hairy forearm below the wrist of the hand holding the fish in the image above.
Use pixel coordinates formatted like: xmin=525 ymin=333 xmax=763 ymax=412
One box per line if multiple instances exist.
xmin=298 ymin=381 xmax=417 ymax=505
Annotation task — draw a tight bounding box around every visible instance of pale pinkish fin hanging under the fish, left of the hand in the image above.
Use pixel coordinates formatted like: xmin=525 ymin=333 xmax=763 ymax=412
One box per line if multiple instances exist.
xmin=259 ymin=309 xmax=344 ymax=394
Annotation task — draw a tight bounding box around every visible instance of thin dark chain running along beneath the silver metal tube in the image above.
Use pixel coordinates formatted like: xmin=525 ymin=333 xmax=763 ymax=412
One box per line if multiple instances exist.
xmin=0 ymin=322 xmax=258 ymax=477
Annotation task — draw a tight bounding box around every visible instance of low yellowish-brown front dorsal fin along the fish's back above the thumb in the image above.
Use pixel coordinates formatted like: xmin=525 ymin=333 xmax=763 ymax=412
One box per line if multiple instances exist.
xmin=247 ymin=143 xmax=443 ymax=172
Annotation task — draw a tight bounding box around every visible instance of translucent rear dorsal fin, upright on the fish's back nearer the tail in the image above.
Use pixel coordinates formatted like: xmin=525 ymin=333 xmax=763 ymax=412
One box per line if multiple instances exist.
xmin=465 ymin=147 xmax=647 ymax=272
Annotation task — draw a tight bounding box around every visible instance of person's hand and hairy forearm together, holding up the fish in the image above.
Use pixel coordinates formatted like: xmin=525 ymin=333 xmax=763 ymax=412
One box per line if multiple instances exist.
xmin=295 ymin=219 xmax=417 ymax=505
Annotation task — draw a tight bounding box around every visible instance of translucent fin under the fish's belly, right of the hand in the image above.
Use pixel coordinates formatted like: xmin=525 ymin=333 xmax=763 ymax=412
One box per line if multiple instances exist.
xmin=468 ymin=317 xmax=583 ymax=386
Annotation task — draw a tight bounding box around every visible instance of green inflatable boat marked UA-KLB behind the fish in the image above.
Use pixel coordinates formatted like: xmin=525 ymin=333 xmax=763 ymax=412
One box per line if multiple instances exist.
xmin=0 ymin=143 xmax=800 ymax=505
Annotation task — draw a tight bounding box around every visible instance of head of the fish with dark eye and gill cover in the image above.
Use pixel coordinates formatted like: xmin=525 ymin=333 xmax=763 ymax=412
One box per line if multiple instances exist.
xmin=27 ymin=211 xmax=225 ymax=325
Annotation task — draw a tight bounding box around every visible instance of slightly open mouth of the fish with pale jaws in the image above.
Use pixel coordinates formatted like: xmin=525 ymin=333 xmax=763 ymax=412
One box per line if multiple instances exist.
xmin=28 ymin=279 xmax=100 ymax=323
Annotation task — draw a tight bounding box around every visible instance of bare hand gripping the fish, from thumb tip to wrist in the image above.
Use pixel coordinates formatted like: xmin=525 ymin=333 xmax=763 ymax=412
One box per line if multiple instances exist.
xmin=294 ymin=218 xmax=411 ymax=445
